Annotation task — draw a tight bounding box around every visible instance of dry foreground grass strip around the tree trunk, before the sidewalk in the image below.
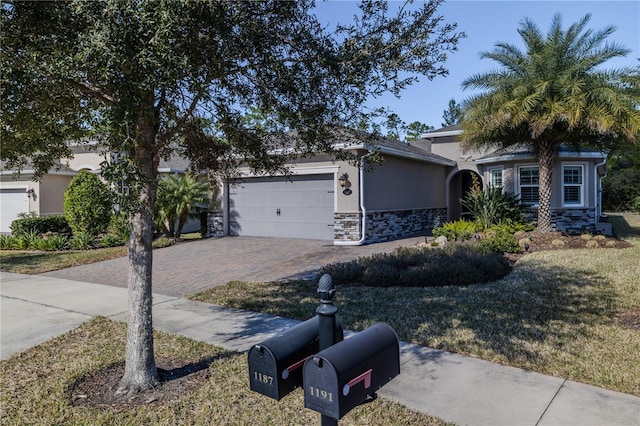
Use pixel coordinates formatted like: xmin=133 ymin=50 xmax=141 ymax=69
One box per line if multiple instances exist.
xmin=0 ymin=318 xmax=448 ymax=426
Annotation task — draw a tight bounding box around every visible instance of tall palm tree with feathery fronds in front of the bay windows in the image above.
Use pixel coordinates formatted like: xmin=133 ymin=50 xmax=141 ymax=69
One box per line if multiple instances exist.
xmin=461 ymin=15 xmax=640 ymax=232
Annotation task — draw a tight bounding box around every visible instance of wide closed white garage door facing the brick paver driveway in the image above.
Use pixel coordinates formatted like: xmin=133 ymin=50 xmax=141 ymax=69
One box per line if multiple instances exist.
xmin=229 ymin=174 xmax=334 ymax=240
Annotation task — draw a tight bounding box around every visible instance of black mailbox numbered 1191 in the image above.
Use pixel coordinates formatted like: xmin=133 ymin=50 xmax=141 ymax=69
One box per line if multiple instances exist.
xmin=303 ymin=323 xmax=400 ymax=420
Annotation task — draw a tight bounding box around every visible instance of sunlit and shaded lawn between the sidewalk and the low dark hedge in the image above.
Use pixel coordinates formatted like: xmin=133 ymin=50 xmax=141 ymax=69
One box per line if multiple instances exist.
xmin=192 ymin=214 xmax=640 ymax=396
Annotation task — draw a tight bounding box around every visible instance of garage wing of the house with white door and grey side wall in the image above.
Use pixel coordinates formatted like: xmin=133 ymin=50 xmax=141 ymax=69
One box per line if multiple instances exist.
xmin=221 ymin=131 xmax=455 ymax=245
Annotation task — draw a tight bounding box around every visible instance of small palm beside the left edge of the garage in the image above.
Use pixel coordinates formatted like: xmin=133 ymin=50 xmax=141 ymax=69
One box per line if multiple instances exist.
xmin=155 ymin=173 xmax=209 ymax=238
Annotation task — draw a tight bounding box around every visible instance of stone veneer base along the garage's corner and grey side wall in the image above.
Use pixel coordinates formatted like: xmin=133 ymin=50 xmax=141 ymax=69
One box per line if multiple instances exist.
xmin=334 ymin=209 xmax=447 ymax=243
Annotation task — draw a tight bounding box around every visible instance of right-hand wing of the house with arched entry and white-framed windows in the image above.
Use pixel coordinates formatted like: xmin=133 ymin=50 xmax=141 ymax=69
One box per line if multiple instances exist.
xmin=422 ymin=126 xmax=611 ymax=234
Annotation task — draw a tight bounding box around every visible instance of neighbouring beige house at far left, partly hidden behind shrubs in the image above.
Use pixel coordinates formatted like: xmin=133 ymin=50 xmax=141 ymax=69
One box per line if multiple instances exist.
xmin=0 ymin=142 xmax=200 ymax=234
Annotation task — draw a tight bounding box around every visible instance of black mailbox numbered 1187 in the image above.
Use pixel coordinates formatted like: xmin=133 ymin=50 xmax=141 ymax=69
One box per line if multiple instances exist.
xmin=248 ymin=316 xmax=343 ymax=400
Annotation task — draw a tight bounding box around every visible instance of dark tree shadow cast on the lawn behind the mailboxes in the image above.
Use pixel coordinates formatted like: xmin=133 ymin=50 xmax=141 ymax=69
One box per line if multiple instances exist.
xmin=202 ymin=255 xmax=616 ymax=372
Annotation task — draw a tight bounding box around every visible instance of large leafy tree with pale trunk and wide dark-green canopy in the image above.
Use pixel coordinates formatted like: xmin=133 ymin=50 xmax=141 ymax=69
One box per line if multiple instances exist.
xmin=0 ymin=0 xmax=461 ymax=393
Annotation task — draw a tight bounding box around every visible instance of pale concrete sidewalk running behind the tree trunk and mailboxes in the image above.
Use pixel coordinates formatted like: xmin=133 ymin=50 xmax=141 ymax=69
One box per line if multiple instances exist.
xmin=0 ymin=272 xmax=640 ymax=426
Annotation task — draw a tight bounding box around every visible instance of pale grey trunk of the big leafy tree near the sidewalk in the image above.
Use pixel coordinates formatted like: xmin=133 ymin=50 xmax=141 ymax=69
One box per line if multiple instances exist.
xmin=116 ymin=112 xmax=160 ymax=395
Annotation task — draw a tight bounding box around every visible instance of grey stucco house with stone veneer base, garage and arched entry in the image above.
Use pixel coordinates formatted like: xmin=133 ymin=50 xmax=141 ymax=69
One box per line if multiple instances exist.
xmin=219 ymin=126 xmax=611 ymax=245
